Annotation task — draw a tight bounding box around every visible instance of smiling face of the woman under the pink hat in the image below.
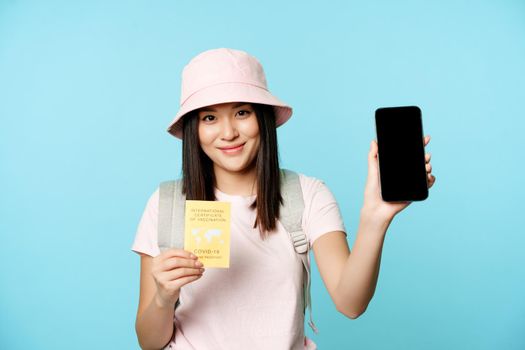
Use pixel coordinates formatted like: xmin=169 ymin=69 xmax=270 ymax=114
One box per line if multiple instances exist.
xmin=198 ymin=102 xmax=260 ymax=175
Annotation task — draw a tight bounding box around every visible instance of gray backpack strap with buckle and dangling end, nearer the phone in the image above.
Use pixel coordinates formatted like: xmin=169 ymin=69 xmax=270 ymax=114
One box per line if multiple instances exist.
xmin=279 ymin=169 xmax=318 ymax=334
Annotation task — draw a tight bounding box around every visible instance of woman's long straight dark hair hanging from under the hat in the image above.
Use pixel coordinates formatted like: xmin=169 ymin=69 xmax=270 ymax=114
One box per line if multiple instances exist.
xmin=182 ymin=103 xmax=283 ymax=239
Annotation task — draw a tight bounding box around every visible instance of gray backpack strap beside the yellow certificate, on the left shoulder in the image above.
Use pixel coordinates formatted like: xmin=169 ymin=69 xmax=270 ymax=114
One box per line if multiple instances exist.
xmin=157 ymin=180 xmax=186 ymax=252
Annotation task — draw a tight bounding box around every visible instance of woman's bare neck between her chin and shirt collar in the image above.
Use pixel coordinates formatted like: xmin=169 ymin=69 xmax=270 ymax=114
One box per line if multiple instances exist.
xmin=214 ymin=166 xmax=257 ymax=196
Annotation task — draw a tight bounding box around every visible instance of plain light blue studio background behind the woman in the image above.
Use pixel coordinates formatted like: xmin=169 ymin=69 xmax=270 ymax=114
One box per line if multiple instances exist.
xmin=0 ymin=0 xmax=525 ymax=349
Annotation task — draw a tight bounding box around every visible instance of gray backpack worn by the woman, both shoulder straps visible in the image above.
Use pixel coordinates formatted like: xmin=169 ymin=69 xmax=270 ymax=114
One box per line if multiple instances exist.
xmin=157 ymin=169 xmax=318 ymax=334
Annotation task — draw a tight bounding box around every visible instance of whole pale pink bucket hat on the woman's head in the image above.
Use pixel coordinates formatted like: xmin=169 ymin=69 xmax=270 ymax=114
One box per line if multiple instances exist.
xmin=168 ymin=48 xmax=292 ymax=139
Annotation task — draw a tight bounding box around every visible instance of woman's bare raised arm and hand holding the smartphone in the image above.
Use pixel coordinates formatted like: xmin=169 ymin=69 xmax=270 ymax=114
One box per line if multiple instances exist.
xmin=313 ymin=136 xmax=436 ymax=319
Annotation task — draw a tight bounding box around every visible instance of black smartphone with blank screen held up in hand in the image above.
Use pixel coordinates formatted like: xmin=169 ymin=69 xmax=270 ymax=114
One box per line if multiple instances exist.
xmin=375 ymin=106 xmax=428 ymax=202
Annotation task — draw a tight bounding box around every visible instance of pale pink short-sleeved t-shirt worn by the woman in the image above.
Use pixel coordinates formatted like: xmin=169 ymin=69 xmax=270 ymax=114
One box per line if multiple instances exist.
xmin=132 ymin=174 xmax=346 ymax=350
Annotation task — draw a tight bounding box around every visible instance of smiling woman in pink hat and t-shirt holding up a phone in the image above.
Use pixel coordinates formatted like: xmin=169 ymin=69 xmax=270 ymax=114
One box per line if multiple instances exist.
xmin=132 ymin=49 xmax=435 ymax=350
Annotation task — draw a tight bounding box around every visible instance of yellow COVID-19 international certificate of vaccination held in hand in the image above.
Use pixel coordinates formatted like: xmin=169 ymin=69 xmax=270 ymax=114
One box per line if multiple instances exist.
xmin=184 ymin=200 xmax=230 ymax=268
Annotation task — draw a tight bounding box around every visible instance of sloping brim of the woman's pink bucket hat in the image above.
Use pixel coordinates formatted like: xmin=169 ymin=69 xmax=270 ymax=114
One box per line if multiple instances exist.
xmin=167 ymin=83 xmax=292 ymax=139
